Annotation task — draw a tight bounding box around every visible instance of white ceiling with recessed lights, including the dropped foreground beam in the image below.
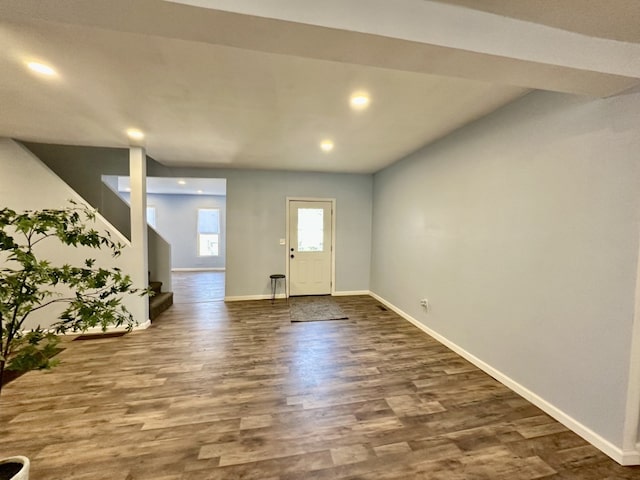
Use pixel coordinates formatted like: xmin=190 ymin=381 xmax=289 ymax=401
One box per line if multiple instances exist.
xmin=0 ymin=0 xmax=640 ymax=173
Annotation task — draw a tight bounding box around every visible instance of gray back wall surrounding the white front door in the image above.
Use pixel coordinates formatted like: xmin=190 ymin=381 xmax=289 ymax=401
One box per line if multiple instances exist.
xmin=148 ymin=168 xmax=373 ymax=297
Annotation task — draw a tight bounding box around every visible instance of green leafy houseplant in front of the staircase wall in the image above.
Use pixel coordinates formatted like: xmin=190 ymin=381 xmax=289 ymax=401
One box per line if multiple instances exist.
xmin=0 ymin=202 xmax=148 ymax=392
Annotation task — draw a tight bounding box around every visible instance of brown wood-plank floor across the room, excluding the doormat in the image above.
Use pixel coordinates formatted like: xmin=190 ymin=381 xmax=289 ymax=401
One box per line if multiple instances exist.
xmin=0 ymin=272 xmax=640 ymax=480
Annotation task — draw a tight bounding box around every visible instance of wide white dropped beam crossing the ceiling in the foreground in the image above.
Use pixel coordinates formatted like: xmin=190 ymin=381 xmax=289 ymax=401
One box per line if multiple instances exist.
xmin=0 ymin=0 xmax=640 ymax=97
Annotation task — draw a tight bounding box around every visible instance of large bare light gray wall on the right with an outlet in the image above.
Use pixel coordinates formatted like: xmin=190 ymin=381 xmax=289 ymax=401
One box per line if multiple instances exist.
xmin=371 ymin=92 xmax=640 ymax=446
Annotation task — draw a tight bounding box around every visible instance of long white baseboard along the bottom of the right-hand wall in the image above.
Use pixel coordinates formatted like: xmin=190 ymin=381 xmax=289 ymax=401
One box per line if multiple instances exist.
xmin=370 ymin=292 xmax=640 ymax=466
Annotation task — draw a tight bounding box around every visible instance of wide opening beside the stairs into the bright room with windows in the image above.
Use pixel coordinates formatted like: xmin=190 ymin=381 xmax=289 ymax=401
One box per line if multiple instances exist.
xmin=102 ymin=176 xmax=227 ymax=303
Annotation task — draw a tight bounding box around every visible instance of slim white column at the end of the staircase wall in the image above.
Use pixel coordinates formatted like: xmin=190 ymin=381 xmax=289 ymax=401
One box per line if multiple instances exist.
xmin=129 ymin=147 xmax=149 ymax=324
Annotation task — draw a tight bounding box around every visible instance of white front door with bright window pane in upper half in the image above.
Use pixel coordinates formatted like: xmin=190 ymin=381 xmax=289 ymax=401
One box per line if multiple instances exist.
xmin=287 ymin=200 xmax=333 ymax=295
